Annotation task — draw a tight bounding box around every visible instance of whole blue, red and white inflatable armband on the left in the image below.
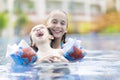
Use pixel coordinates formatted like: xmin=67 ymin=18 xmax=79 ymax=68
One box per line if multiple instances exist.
xmin=6 ymin=40 xmax=37 ymax=65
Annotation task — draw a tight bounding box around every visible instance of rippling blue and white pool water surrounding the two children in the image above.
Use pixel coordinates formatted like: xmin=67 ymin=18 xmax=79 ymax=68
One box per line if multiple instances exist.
xmin=0 ymin=36 xmax=120 ymax=80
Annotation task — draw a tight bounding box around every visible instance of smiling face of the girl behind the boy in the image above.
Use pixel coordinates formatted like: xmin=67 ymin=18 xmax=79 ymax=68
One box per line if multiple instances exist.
xmin=47 ymin=11 xmax=68 ymax=38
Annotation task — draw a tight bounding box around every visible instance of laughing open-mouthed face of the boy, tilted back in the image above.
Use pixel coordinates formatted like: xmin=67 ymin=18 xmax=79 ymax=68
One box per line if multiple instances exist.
xmin=30 ymin=25 xmax=49 ymax=43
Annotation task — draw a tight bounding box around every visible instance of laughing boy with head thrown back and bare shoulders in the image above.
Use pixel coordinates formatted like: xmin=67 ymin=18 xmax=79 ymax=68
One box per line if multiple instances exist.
xmin=30 ymin=24 xmax=68 ymax=63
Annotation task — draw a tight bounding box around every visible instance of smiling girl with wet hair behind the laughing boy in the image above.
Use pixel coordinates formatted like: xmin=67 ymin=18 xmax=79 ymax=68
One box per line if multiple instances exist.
xmin=46 ymin=10 xmax=68 ymax=48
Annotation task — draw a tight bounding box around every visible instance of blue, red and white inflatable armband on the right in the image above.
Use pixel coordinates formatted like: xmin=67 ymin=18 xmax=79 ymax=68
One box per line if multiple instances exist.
xmin=63 ymin=38 xmax=86 ymax=62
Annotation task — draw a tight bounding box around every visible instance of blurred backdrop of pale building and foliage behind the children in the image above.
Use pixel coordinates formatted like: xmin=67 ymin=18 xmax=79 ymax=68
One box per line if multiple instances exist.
xmin=0 ymin=0 xmax=120 ymax=36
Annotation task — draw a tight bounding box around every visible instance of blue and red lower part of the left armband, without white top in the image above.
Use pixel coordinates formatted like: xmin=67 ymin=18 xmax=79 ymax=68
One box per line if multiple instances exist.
xmin=10 ymin=47 xmax=37 ymax=65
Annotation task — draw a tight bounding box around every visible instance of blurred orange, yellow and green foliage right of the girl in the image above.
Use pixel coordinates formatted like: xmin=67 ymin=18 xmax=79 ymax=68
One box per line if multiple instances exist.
xmin=68 ymin=8 xmax=120 ymax=34
